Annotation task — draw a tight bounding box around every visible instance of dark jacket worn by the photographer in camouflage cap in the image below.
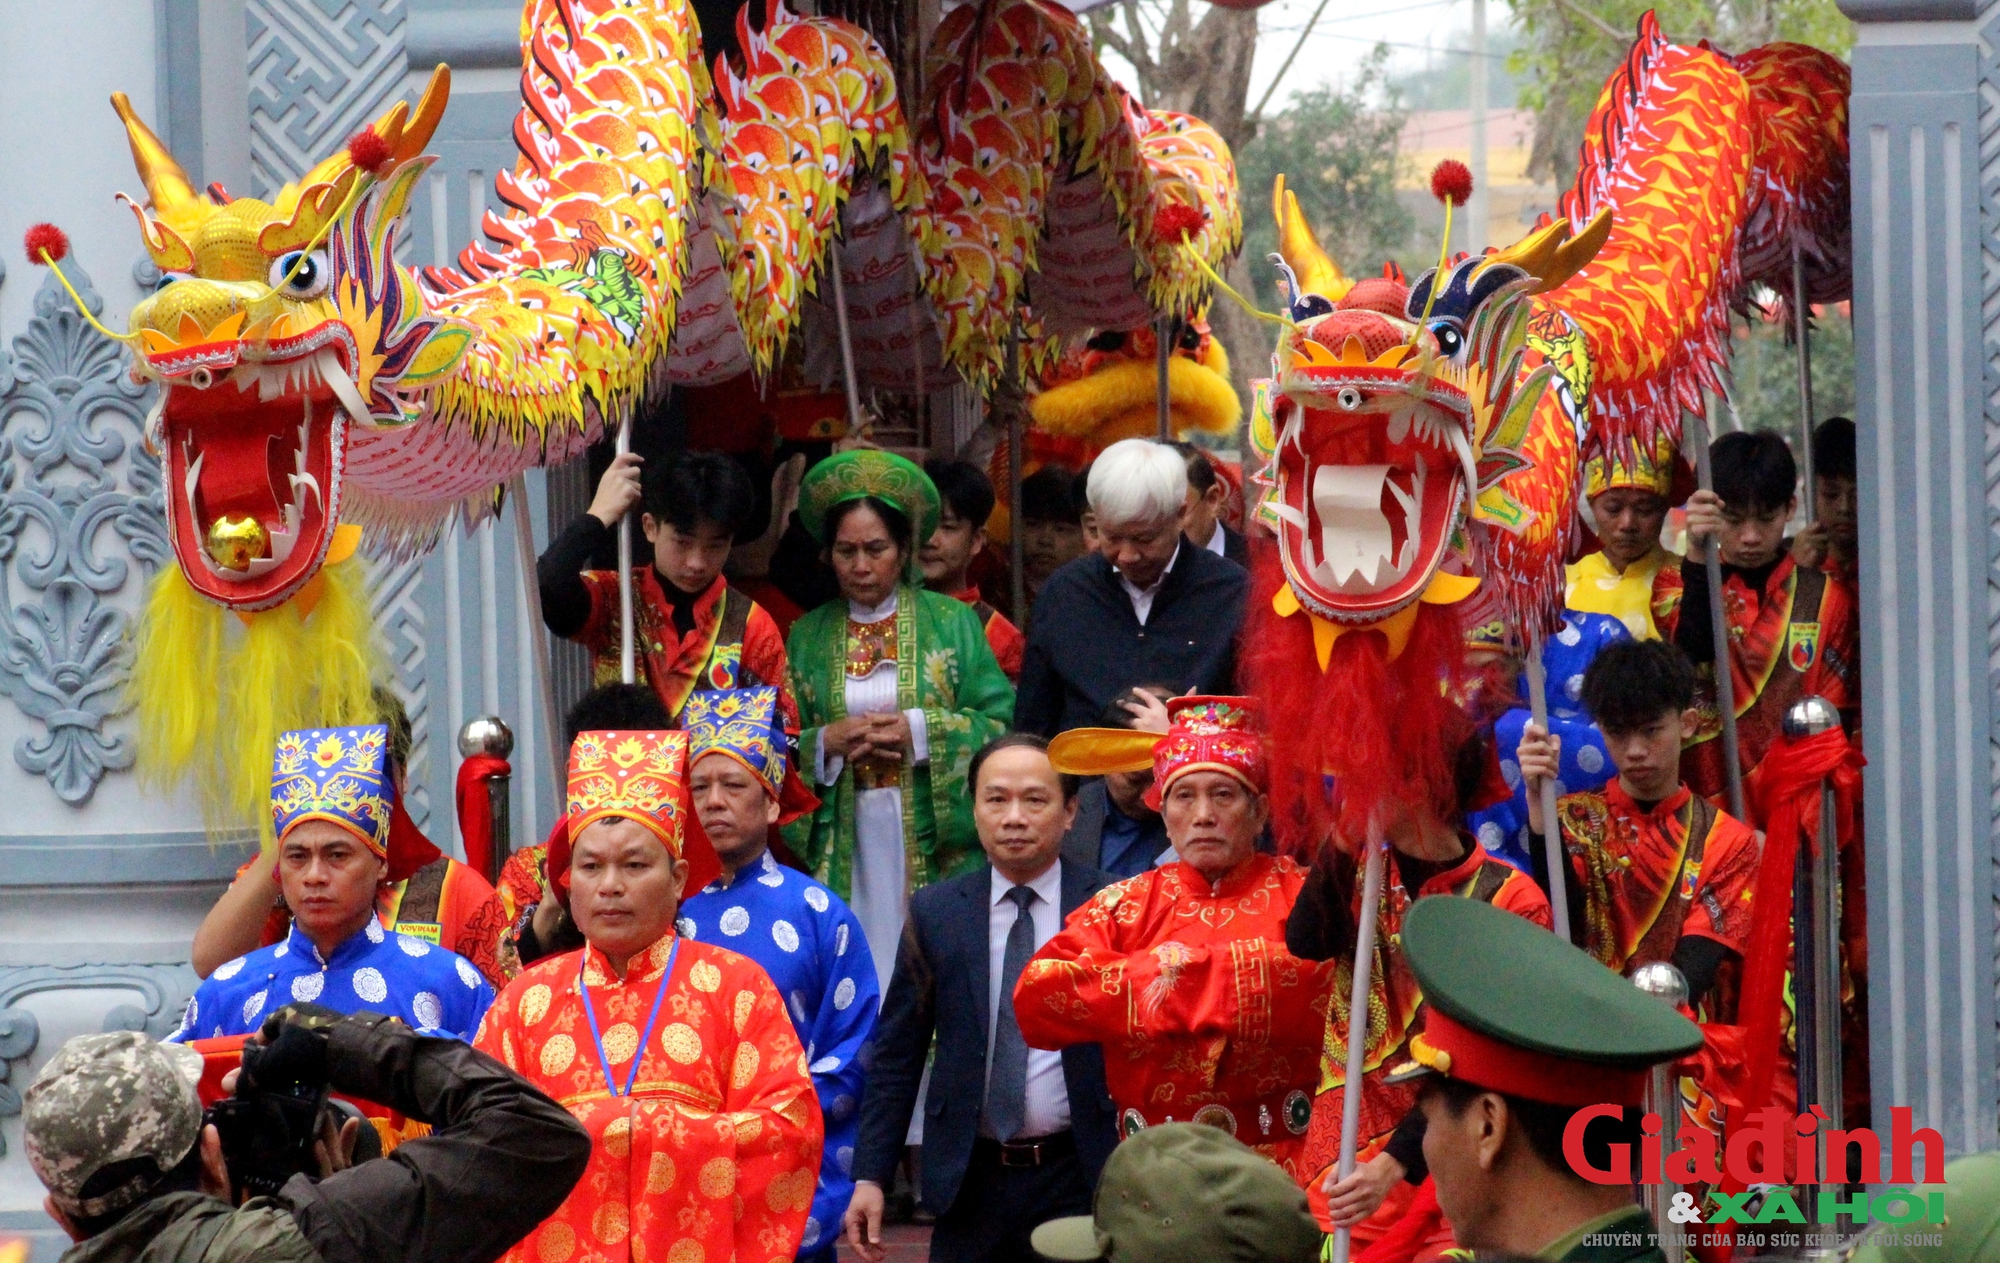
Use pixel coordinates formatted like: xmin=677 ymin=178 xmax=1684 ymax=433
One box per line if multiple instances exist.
xmin=62 ymin=1013 xmax=590 ymax=1263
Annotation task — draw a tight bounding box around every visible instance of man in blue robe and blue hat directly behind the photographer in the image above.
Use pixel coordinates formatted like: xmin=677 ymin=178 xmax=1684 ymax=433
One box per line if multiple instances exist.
xmin=170 ymin=723 xmax=494 ymax=1041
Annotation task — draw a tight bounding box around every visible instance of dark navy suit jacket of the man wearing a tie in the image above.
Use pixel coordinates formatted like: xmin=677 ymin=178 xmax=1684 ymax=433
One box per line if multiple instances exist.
xmin=854 ymin=861 xmax=1118 ymax=1215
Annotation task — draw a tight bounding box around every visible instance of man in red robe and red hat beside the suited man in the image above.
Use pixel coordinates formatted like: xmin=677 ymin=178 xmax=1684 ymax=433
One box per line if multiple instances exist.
xmin=1014 ymin=697 xmax=1334 ymax=1181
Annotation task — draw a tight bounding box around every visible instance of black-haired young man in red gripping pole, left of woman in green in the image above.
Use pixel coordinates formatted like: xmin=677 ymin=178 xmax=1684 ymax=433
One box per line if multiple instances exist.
xmin=536 ymin=450 xmax=798 ymax=733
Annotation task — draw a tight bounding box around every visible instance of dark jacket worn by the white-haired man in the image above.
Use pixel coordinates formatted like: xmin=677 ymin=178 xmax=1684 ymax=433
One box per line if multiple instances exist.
xmin=1014 ymin=540 xmax=1250 ymax=737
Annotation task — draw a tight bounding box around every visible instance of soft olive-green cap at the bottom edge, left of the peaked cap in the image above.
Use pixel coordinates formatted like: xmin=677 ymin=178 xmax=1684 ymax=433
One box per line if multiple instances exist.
xmin=1032 ymin=1123 xmax=1326 ymax=1263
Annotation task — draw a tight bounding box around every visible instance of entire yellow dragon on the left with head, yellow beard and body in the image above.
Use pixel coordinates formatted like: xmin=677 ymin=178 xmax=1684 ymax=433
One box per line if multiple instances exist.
xmin=101 ymin=0 xmax=1240 ymax=823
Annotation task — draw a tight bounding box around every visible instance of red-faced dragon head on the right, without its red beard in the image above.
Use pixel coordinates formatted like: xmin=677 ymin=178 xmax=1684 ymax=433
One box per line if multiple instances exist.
xmin=1252 ymin=176 xmax=1610 ymax=643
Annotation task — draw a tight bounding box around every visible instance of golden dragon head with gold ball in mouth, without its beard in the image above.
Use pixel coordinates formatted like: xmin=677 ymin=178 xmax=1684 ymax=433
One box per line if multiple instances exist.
xmin=112 ymin=66 xmax=472 ymax=612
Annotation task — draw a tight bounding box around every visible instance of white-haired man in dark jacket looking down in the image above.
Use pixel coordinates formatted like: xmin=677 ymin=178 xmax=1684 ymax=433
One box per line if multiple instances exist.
xmin=1014 ymin=438 xmax=1250 ymax=737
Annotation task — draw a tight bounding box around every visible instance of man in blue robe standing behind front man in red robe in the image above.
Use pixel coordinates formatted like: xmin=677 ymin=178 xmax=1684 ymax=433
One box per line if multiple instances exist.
xmin=680 ymin=687 xmax=882 ymax=1263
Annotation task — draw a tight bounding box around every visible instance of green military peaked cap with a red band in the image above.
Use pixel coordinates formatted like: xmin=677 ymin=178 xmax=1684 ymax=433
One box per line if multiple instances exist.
xmin=1390 ymin=897 xmax=1702 ymax=1105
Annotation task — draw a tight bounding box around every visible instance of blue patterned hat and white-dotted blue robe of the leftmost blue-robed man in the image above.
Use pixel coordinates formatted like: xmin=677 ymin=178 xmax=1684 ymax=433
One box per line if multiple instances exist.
xmin=168 ymin=723 xmax=494 ymax=1041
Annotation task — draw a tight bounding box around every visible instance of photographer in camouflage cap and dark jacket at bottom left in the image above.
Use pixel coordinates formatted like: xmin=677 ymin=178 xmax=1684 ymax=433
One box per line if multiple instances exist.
xmin=22 ymin=1005 xmax=590 ymax=1263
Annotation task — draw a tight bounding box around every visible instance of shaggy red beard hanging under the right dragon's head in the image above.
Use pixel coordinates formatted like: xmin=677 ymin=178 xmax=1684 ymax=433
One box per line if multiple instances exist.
xmin=1242 ymin=542 xmax=1476 ymax=859
